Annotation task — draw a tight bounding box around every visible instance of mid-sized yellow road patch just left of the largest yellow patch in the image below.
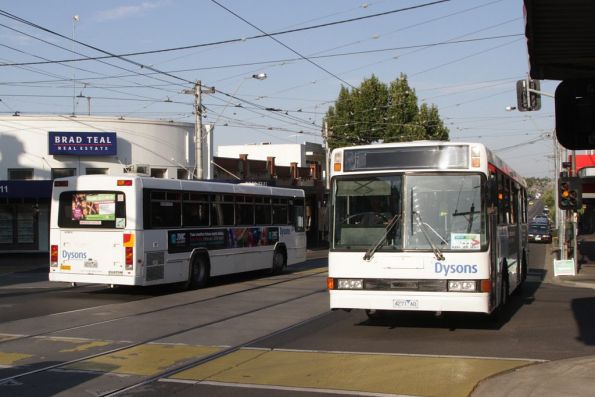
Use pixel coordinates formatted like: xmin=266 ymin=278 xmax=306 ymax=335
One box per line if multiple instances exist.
xmin=65 ymin=344 xmax=221 ymax=376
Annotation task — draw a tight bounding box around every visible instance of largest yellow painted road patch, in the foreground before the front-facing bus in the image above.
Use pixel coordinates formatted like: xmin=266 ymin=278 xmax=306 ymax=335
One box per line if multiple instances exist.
xmin=172 ymin=349 xmax=532 ymax=397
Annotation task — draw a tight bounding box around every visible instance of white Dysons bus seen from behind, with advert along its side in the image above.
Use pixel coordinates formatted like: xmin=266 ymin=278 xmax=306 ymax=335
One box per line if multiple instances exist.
xmin=49 ymin=175 xmax=306 ymax=288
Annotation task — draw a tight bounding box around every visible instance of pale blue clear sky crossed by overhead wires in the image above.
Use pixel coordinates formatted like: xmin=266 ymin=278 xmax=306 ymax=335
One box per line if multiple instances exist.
xmin=0 ymin=0 xmax=559 ymax=177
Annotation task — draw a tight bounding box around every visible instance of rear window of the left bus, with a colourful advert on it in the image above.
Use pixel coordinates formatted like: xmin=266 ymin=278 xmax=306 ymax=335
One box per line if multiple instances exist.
xmin=58 ymin=191 xmax=126 ymax=229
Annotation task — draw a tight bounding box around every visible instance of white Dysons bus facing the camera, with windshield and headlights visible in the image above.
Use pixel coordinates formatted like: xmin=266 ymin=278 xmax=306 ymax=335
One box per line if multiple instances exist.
xmin=327 ymin=141 xmax=528 ymax=317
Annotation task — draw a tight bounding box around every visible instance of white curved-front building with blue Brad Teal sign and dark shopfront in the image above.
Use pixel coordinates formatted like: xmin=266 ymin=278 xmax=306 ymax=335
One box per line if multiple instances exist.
xmin=0 ymin=116 xmax=195 ymax=252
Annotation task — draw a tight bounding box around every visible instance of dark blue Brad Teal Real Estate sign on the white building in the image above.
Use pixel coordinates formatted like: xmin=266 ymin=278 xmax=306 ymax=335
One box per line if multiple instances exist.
xmin=49 ymin=131 xmax=118 ymax=156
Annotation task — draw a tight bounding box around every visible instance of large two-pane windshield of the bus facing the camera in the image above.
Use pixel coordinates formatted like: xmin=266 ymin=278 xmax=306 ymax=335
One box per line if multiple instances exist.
xmin=333 ymin=174 xmax=487 ymax=252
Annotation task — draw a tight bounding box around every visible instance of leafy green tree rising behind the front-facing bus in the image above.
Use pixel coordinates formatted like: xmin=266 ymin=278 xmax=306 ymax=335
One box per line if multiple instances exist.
xmin=324 ymin=74 xmax=448 ymax=148
